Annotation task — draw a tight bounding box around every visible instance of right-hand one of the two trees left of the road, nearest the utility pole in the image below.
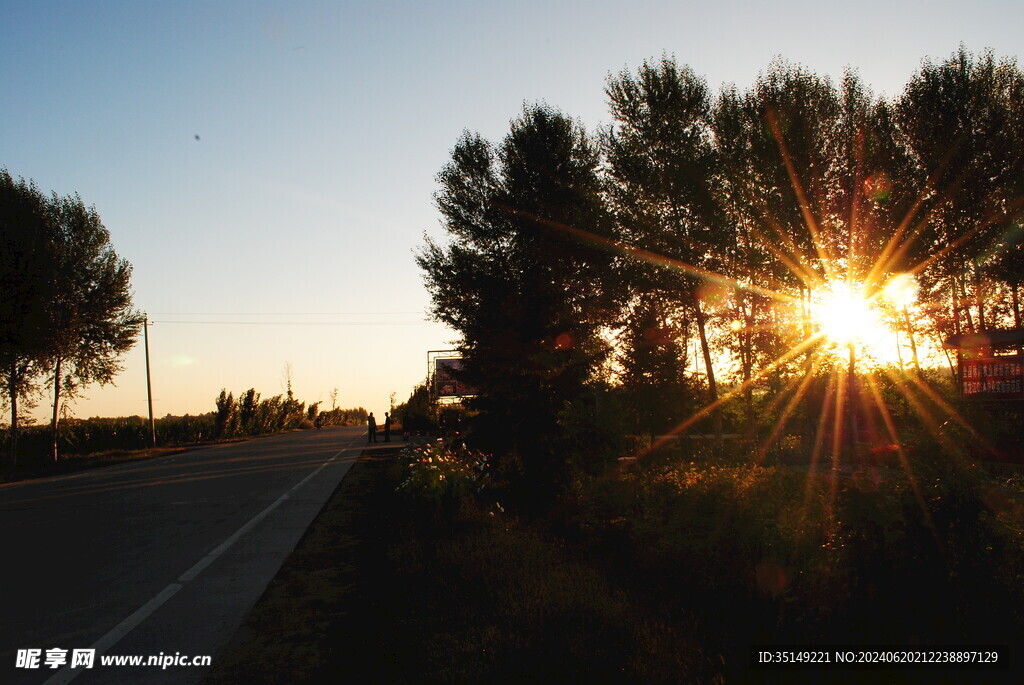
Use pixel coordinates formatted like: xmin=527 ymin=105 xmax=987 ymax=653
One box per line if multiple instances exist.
xmin=46 ymin=195 xmax=143 ymax=461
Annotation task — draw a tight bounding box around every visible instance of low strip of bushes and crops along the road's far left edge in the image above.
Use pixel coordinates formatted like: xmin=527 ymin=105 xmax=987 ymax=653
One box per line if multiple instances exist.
xmin=0 ymin=388 xmax=367 ymax=466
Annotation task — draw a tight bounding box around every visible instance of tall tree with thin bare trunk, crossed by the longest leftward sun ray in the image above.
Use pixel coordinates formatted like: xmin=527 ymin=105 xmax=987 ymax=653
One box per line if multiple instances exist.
xmin=605 ymin=57 xmax=727 ymax=436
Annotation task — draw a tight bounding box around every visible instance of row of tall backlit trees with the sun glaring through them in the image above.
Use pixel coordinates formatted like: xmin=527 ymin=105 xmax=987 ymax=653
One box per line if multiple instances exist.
xmin=418 ymin=48 xmax=1024 ymax=500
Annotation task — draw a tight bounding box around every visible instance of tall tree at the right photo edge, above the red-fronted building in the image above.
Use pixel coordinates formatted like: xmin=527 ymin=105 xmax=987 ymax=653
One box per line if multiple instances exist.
xmin=895 ymin=47 xmax=1024 ymax=328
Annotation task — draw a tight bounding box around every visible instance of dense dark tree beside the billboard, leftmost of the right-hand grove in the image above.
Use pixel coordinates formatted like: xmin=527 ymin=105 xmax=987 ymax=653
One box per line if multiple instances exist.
xmin=417 ymin=105 xmax=613 ymax=497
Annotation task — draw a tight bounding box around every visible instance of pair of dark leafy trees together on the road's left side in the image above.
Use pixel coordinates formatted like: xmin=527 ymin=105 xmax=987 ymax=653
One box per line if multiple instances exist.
xmin=0 ymin=169 xmax=141 ymax=460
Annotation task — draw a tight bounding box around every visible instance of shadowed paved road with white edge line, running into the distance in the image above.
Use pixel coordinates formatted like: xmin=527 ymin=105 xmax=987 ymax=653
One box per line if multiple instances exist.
xmin=0 ymin=428 xmax=376 ymax=685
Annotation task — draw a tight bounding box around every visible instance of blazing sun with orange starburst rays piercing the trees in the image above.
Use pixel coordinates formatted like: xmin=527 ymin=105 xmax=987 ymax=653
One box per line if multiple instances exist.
xmin=529 ymin=114 xmax=1024 ymax=530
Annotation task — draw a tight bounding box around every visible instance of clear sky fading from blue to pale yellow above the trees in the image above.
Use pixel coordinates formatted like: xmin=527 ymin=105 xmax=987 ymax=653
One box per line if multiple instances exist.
xmin=0 ymin=0 xmax=1024 ymax=420
